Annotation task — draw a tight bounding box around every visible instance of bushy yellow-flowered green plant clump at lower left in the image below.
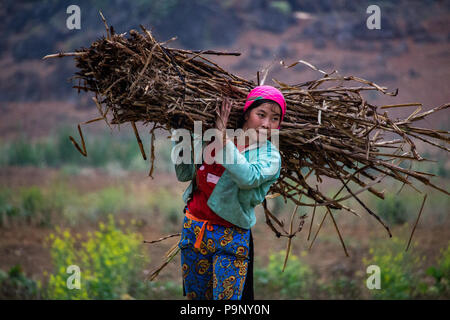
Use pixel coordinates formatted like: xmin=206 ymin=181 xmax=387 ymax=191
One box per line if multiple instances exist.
xmin=46 ymin=215 xmax=148 ymax=299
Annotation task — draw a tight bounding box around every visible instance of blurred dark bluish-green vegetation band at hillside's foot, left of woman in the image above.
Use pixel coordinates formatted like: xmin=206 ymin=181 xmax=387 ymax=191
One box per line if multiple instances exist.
xmin=0 ymin=126 xmax=174 ymax=174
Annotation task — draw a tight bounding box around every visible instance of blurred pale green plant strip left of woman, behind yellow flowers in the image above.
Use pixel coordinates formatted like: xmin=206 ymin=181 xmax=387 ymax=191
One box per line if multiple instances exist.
xmin=0 ymin=180 xmax=184 ymax=231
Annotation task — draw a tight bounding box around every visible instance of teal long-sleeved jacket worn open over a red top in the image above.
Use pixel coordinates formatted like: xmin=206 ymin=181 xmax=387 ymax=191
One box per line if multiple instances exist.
xmin=174 ymin=134 xmax=281 ymax=229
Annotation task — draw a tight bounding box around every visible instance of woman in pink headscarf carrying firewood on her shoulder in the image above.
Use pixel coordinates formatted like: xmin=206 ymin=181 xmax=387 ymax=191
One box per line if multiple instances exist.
xmin=175 ymin=86 xmax=286 ymax=300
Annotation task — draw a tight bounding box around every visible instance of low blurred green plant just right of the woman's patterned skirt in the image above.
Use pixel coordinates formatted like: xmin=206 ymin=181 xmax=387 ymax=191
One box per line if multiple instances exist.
xmin=254 ymin=251 xmax=316 ymax=299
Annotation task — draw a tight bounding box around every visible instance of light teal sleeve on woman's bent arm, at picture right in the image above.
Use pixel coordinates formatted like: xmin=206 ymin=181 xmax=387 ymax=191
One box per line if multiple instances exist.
xmin=216 ymin=141 xmax=281 ymax=189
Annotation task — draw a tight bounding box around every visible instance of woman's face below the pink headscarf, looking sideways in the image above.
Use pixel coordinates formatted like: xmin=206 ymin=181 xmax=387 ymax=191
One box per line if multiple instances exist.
xmin=242 ymin=102 xmax=281 ymax=131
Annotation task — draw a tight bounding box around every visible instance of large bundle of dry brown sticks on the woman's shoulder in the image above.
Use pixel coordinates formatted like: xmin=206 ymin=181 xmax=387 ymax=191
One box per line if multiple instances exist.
xmin=45 ymin=17 xmax=450 ymax=249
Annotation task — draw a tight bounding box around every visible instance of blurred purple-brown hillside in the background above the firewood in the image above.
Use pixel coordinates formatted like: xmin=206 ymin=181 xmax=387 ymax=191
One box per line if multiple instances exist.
xmin=0 ymin=0 xmax=450 ymax=139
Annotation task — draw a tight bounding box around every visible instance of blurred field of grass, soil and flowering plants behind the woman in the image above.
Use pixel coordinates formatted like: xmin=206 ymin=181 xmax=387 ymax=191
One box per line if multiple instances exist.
xmin=0 ymin=130 xmax=450 ymax=299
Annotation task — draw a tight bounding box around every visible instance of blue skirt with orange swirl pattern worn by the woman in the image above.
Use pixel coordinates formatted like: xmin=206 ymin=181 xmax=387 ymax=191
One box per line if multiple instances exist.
xmin=178 ymin=216 xmax=250 ymax=300
